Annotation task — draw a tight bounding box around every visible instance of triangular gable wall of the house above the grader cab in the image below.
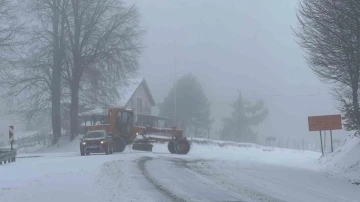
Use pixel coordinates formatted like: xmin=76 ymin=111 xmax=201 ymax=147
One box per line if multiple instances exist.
xmin=125 ymin=83 xmax=151 ymax=114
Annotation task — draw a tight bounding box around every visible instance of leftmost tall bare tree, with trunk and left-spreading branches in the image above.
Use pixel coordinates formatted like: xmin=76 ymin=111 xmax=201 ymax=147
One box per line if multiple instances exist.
xmin=1 ymin=0 xmax=68 ymax=144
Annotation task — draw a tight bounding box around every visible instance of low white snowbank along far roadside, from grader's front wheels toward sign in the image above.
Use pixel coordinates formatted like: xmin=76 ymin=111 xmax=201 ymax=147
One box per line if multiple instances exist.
xmin=153 ymin=139 xmax=321 ymax=170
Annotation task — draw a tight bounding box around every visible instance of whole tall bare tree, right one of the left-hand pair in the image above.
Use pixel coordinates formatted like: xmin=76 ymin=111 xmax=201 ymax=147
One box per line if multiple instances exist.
xmin=65 ymin=0 xmax=143 ymax=139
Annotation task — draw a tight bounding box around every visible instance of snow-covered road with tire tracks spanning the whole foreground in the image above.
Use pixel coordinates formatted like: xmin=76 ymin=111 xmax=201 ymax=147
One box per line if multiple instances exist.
xmin=0 ymin=144 xmax=360 ymax=202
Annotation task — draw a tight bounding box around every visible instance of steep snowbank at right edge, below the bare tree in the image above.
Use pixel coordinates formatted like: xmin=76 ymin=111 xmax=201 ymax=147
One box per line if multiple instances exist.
xmin=319 ymin=136 xmax=360 ymax=184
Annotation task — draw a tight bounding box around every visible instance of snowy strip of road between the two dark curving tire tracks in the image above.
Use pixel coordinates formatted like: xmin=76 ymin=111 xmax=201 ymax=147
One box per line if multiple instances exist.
xmin=142 ymin=157 xmax=249 ymax=202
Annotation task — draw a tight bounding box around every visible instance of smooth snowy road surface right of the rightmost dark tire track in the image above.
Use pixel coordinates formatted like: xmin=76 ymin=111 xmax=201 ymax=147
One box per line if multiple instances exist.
xmin=193 ymin=161 xmax=360 ymax=202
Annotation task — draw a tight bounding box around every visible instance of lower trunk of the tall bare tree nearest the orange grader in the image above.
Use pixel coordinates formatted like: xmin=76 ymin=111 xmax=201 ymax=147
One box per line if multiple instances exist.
xmin=70 ymin=78 xmax=80 ymax=140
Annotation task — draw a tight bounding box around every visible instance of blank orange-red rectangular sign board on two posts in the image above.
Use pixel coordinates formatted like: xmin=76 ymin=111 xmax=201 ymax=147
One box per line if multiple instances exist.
xmin=308 ymin=115 xmax=342 ymax=131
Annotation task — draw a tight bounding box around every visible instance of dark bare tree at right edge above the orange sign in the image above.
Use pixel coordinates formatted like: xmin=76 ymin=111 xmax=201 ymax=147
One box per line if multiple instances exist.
xmin=295 ymin=0 xmax=360 ymax=130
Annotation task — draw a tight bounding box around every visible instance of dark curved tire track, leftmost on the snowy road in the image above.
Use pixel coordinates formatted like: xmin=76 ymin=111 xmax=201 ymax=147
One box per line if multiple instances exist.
xmin=138 ymin=157 xmax=186 ymax=202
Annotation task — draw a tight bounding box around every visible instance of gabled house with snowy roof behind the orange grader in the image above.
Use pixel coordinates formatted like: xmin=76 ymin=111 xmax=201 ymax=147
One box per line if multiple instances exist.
xmin=79 ymin=78 xmax=171 ymax=128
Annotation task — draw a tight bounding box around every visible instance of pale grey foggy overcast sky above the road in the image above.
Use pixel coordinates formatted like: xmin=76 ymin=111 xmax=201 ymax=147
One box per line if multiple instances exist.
xmin=130 ymin=0 xmax=354 ymax=145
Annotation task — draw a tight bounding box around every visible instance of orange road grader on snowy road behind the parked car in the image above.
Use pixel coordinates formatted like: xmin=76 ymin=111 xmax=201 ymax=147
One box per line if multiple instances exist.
xmin=86 ymin=108 xmax=190 ymax=154
